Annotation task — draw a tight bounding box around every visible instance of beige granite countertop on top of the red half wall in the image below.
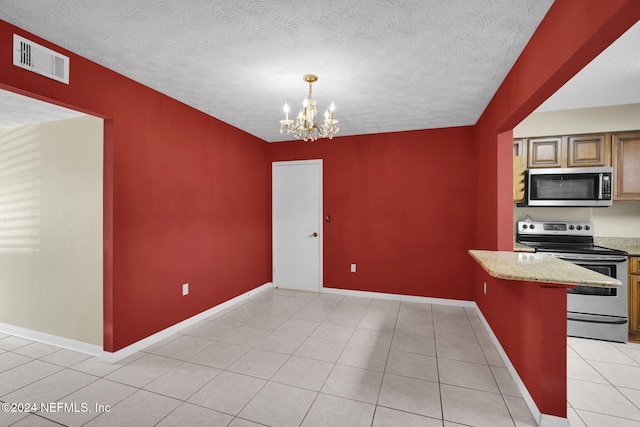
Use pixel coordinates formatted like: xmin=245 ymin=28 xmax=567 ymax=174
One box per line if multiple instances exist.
xmin=469 ymin=249 xmax=622 ymax=287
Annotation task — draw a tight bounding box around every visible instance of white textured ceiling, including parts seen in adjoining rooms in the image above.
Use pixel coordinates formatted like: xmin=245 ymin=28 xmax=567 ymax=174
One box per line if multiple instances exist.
xmin=0 ymin=0 xmax=640 ymax=142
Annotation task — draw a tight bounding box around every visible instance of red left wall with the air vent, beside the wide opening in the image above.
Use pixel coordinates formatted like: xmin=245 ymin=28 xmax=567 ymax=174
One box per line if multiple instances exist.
xmin=0 ymin=21 xmax=271 ymax=351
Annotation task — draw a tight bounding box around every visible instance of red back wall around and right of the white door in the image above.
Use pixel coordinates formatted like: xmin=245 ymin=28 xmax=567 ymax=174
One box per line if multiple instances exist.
xmin=268 ymin=127 xmax=476 ymax=300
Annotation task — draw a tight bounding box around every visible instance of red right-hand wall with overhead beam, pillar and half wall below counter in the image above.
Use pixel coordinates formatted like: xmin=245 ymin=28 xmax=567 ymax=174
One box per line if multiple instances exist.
xmin=473 ymin=0 xmax=640 ymax=417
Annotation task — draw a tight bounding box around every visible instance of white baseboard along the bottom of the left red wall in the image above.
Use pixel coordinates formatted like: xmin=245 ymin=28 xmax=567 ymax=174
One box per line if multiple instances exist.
xmin=101 ymin=282 xmax=273 ymax=363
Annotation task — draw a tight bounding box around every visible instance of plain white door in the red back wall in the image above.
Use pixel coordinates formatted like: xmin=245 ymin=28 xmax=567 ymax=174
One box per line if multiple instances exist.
xmin=272 ymin=160 xmax=322 ymax=291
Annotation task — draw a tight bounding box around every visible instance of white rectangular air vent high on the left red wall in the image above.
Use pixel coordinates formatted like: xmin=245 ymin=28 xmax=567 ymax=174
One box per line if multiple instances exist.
xmin=13 ymin=34 xmax=69 ymax=84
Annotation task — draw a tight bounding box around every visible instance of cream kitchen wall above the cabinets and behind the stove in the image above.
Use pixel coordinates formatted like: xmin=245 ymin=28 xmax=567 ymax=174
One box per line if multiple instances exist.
xmin=513 ymin=104 xmax=640 ymax=237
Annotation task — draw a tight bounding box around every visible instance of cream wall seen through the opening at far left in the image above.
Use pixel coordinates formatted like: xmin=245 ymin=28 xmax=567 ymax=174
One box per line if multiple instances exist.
xmin=0 ymin=116 xmax=103 ymax=347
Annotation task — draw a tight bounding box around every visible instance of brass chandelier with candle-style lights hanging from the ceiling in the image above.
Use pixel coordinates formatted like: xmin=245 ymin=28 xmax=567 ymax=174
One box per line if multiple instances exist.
xmin=280 ymin=74 xmax=340 ymax=141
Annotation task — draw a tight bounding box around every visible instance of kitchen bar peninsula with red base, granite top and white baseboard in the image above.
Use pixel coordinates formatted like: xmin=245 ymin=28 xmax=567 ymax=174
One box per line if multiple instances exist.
xmin=468 ymin=250 xmax=621 ymax=427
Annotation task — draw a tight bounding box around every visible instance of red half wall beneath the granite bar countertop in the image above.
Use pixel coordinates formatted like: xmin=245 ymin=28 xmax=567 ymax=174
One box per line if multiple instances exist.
xmin=477 ymin=266 xmax=567 ymax=417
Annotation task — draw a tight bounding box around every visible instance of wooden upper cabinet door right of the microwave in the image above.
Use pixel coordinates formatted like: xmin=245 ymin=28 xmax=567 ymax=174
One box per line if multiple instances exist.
xmin=613 ymin=132 xmax=640 ymax=202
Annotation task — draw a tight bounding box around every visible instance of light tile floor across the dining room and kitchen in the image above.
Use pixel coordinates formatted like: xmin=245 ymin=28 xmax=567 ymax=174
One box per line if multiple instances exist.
xmin=0 ymin=289 xmax=640 ymax=427
